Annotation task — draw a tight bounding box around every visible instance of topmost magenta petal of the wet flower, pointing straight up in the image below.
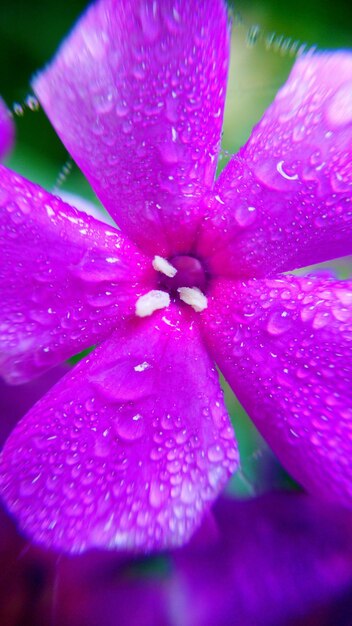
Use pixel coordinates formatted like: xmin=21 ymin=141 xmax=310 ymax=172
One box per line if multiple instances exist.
xmin=34 ymin=0 xmax=229 ymax=254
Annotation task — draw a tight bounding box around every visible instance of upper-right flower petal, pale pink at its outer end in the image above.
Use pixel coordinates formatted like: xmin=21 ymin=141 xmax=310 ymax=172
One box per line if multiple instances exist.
xmin=200 ymin=52 xmax=352 ymax=277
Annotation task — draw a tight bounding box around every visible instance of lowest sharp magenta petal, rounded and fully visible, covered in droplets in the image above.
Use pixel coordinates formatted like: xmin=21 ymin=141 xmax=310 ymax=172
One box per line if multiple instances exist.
xmin=1 ymin=310 xmax=238 ymax=552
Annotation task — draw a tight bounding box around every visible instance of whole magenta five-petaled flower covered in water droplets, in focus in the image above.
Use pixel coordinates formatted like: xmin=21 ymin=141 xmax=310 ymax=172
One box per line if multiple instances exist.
xmin=0 ymin=0 xmax=352 ymax=552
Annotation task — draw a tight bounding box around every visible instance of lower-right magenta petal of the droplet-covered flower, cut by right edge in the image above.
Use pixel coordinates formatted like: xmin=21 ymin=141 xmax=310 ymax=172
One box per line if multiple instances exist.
xmin=202 ymin=276 xmax=352 ymax=506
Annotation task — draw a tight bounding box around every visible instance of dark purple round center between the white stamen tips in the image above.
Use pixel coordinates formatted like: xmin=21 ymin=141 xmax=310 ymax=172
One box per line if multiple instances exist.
xmin=160 ymin=255 xmax=207 ymax=293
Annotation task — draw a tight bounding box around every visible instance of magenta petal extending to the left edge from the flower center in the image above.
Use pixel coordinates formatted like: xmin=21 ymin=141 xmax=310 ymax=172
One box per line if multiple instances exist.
xmin=0 ymin=166 xmax=155 ymax=383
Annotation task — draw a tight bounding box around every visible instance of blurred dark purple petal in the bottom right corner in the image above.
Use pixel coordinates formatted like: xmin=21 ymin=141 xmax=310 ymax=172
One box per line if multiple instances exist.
xmin=171 ymin=494 xmax=352 ymax=626
